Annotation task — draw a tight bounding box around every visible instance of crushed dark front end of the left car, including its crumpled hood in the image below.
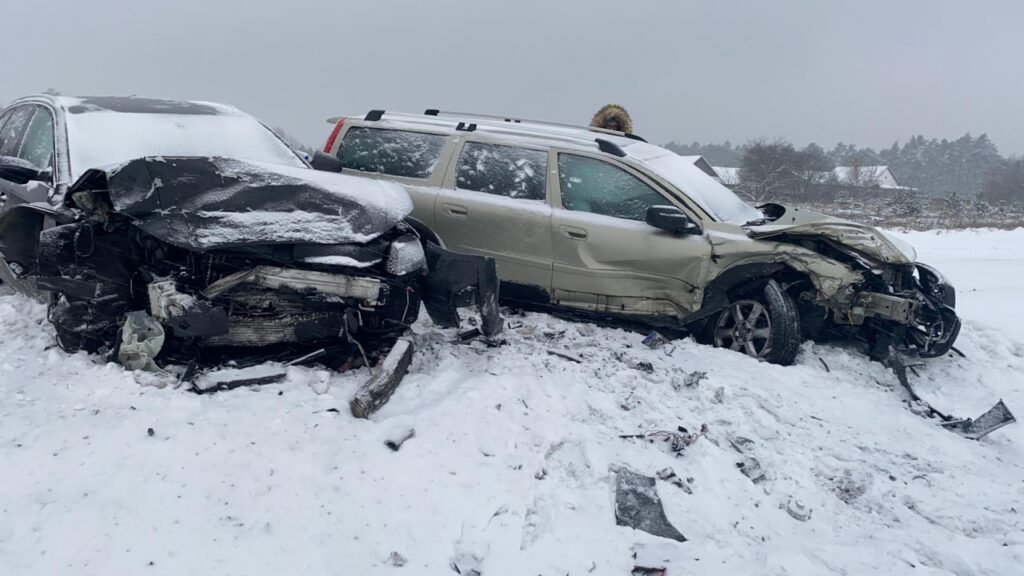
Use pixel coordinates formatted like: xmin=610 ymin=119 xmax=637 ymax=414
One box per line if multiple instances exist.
xmin=4 ymin=154 xmax=501 ymax=366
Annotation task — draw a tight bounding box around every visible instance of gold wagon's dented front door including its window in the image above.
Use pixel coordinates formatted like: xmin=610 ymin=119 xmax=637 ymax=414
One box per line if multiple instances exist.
xmin=551 ymin=152 xmax=711 ymax=321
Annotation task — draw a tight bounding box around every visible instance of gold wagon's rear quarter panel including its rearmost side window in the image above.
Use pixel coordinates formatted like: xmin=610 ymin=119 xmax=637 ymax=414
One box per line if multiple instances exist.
xmin=338 ymin=126 xmax=454 ymax=229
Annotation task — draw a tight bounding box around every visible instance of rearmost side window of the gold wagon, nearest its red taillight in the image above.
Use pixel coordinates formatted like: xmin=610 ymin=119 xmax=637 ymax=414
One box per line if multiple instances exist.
xmin=338 ymin=126 xmax=445 ymax=178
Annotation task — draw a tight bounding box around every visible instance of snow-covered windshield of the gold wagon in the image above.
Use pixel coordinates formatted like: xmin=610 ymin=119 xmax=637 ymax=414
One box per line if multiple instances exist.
xmin=630 ymin=145 xmax=764 ymax=224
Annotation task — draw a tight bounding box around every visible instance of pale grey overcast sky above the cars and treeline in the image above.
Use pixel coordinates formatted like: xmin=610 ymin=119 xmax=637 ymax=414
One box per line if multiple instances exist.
xmin=8 ymin=0 xmax=1024 ymax=155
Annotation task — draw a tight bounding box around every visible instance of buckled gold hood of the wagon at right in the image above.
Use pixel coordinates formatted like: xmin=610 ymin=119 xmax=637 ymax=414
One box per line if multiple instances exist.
xmin=743 ymin=206 xmax=918 ymax=264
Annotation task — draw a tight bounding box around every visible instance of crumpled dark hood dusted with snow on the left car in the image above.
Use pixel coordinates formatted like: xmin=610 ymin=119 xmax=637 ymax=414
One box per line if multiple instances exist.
xmin=71 ymin=153 xmax=413 ymax=251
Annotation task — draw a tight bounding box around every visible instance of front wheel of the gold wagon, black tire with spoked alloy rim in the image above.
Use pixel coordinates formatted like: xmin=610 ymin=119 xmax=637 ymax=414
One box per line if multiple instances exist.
xmin=703 ymin=280 xmax=803 ymax=366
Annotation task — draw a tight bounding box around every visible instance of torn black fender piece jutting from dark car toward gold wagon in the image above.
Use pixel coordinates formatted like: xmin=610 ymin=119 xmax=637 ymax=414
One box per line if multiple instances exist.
xmin=421 ymin=241 xmax=502 ymax=337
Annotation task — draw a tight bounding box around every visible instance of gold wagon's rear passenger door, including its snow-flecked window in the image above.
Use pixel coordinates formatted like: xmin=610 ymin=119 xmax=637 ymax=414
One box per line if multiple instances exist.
xmin=434 ymin=140 xmax=552 ymax=302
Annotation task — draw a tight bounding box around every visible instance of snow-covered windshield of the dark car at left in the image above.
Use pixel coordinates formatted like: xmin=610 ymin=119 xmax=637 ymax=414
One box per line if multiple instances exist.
xmin=65 ymin=98 xmax=305 ymax=181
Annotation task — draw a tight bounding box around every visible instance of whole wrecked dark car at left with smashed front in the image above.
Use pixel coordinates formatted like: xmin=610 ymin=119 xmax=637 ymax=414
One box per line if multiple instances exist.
xmin=0 ymin=96 xmax=501 ymax=368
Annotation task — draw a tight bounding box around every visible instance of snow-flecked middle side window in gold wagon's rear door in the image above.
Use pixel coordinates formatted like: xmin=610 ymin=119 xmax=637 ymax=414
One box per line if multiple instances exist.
xmin=456 ymin=142 xmax=548 ymax=201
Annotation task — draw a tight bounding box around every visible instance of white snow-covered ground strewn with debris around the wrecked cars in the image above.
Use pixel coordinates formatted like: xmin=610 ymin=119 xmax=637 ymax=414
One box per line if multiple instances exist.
xmin=0 ymin=230 xmax=1024 ymax=576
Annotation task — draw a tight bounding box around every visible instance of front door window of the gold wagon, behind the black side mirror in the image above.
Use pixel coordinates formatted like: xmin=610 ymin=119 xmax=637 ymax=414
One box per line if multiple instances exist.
xmin=558 ymin=154 xmax=669 ymax=221
